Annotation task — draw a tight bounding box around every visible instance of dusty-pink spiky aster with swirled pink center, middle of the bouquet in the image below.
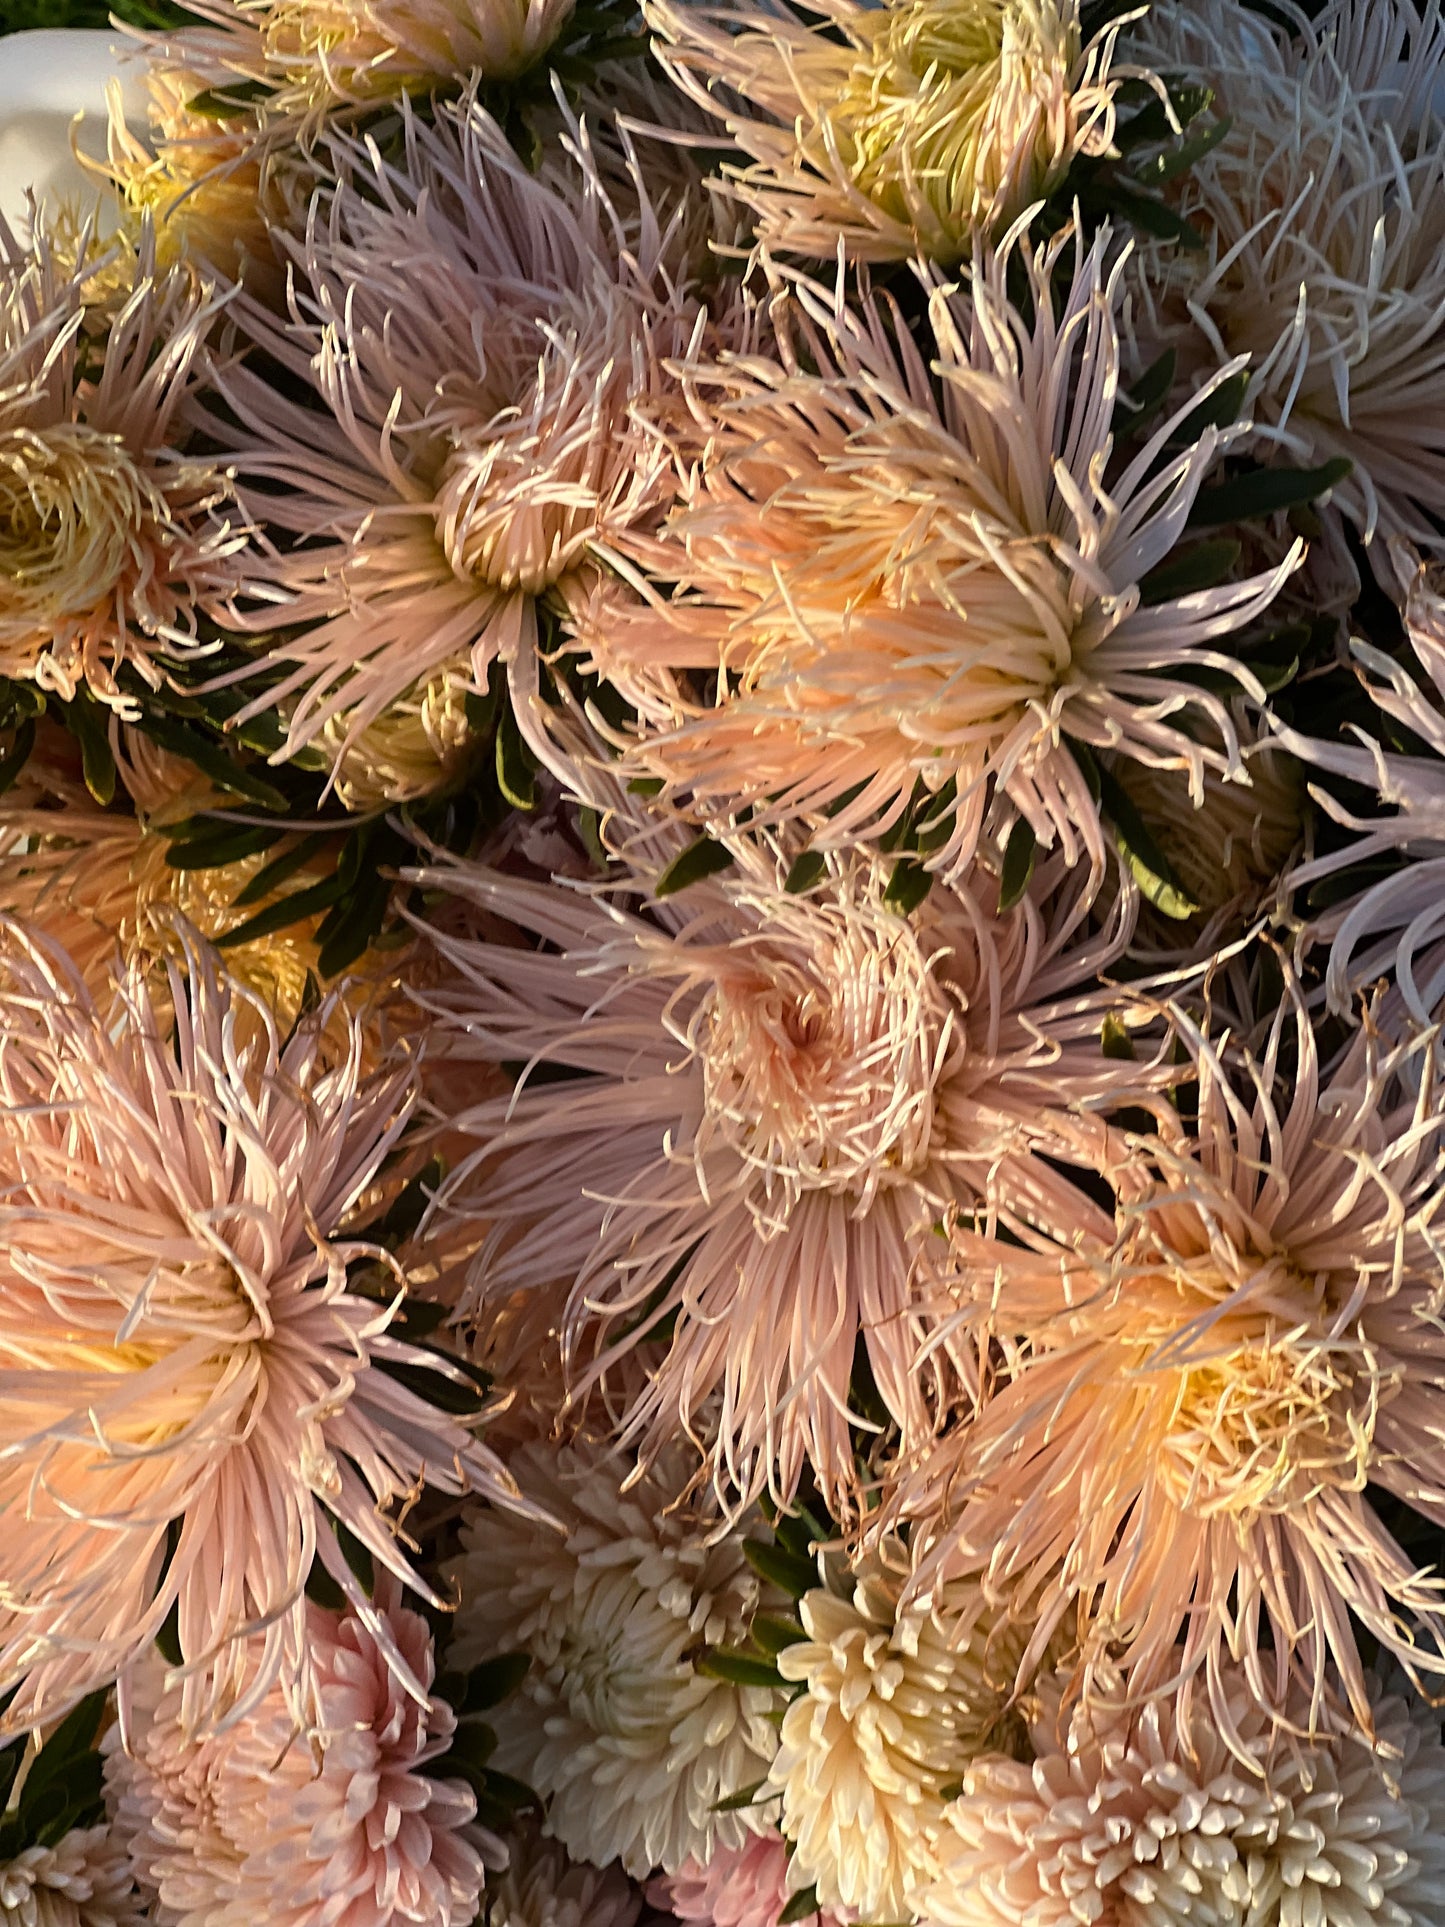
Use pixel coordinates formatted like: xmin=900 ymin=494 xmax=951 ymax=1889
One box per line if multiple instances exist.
xmin=416 ymin=800 xmax=1143 ymax=1517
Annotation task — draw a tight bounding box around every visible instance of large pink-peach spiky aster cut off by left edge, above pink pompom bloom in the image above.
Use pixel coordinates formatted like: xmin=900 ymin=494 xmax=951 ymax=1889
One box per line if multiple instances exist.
xmin=0 ymin=925 xmax=524 ymax=1732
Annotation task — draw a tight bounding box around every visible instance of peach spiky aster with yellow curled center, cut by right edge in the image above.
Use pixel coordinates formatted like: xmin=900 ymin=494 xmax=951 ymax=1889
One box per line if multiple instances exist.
xmin=894 ymin=983 xmax=1445 ymax=1727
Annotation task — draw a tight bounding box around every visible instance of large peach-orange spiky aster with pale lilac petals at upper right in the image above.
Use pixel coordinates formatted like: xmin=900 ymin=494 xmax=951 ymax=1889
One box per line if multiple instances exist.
xmin=601 ymin=225 xmax=1301 ymax=871
